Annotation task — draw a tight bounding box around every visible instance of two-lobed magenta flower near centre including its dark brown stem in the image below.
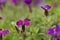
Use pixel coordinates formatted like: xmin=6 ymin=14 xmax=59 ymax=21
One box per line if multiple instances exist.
xmin=16 ymin=18 xmax=30 ymax=32
